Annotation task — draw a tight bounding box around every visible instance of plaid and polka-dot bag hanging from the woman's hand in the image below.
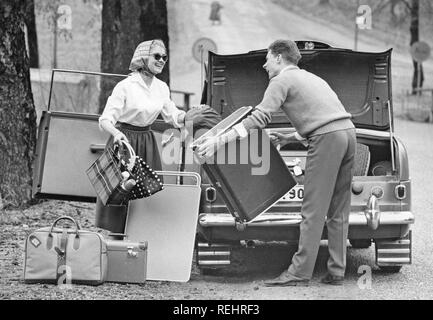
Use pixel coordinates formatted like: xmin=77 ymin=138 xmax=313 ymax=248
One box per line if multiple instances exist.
xmin=86 ymin=141 xmax=163 ymax=205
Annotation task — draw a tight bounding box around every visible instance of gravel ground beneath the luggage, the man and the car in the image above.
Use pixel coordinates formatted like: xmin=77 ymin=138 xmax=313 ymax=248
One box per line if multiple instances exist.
xmin=0 ymin=119 xmax=433 ymax=300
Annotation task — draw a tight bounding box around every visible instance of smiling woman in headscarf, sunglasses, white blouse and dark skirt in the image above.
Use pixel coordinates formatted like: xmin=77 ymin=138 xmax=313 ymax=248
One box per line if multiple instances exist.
xmin=96 ymin=39 xmax=185 ymax=233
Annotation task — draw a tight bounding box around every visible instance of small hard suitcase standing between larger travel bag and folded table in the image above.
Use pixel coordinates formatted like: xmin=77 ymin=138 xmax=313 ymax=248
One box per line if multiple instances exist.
xmin=106 ymin=239 xmax=147 ymax=283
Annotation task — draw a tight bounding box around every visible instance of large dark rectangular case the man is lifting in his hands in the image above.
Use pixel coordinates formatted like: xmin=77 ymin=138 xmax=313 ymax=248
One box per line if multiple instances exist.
xmin=194 ymin=107 xmax=296 ymax=224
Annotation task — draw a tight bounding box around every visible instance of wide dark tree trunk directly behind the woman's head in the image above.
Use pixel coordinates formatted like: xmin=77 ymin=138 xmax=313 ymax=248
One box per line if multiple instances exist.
xmin=99 ymin=0 xmax=170 ymax=113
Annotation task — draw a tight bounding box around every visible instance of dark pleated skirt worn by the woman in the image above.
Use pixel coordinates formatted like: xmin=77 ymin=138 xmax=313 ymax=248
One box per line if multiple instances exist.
xmin=95 ymin=123 xmax=162 ymax=234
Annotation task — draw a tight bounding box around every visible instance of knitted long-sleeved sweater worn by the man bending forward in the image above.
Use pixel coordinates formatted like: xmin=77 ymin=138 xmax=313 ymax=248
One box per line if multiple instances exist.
xmin=242 ymin=66 xmax=354 ymax=138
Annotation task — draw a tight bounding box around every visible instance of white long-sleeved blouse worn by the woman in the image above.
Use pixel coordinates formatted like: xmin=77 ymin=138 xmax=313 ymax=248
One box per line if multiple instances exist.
xmin=99 ymin=72 xmax=185 ymax=128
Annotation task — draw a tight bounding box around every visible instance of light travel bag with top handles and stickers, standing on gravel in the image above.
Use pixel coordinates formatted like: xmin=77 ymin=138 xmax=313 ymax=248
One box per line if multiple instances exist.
xmin=24 ymin=216 xmax=107 ymax=285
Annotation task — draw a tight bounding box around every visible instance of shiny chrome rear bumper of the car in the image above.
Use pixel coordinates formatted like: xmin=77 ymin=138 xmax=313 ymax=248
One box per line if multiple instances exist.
xmin=198 ymin=211 xmax=415 ymax=228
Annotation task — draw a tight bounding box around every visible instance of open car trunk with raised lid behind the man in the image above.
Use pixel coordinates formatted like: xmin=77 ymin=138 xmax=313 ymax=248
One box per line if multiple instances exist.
xmin=202 ymin=41 xmax=395 ymax=175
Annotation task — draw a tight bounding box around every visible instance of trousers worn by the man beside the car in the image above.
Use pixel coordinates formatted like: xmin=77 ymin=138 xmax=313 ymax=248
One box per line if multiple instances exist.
xmin=289 ymin=129 xmax=356 ymax=279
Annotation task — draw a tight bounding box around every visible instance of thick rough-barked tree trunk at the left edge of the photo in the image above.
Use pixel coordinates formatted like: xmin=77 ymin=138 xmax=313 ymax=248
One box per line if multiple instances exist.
xmin=0 ymin=0 xmax=36 ymax=207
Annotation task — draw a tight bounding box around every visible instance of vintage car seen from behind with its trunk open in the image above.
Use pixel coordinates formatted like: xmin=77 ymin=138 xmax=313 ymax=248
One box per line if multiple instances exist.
xmin=197 ymin=41 xmax=414 ymax=272
